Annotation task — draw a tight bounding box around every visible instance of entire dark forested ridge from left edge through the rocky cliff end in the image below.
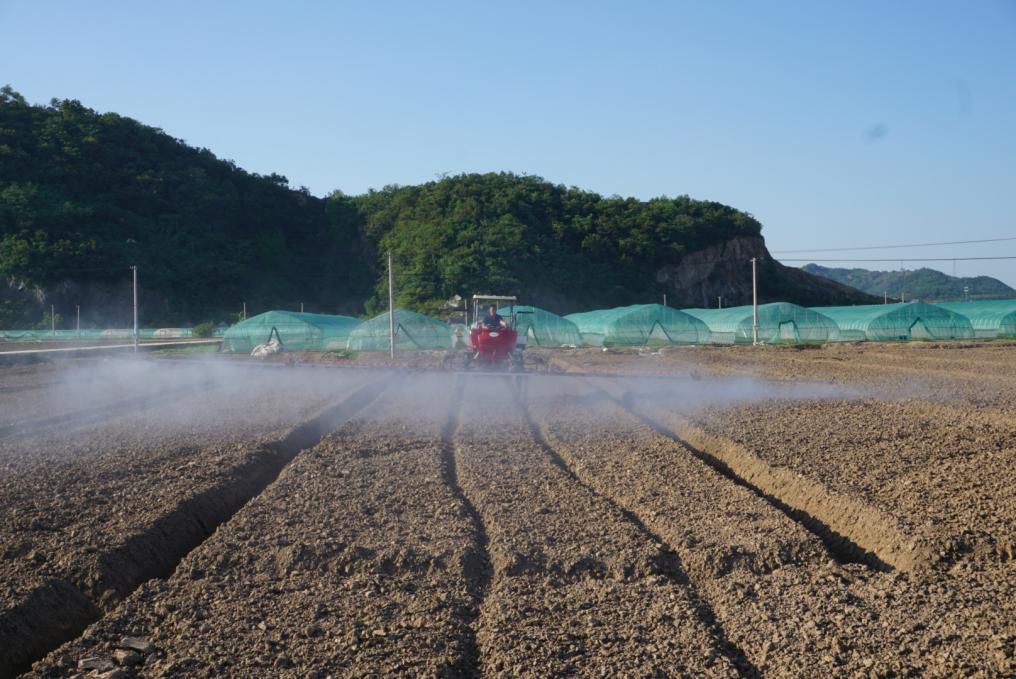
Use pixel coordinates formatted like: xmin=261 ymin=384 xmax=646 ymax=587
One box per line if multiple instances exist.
xmin=0 ymin=87 xmax=867 ymax=327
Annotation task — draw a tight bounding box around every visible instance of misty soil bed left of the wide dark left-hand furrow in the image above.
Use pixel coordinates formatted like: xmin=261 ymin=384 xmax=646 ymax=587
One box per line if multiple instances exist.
xmin=0 ymin=363 xmax=382 ymax=674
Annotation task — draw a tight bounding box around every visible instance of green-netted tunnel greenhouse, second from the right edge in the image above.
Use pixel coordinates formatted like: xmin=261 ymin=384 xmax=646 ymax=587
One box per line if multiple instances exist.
xmin=815 ymin=302 xmax=973 ymax=342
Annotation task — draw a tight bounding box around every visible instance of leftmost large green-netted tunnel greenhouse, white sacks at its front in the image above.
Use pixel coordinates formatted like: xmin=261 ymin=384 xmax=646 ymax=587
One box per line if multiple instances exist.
xmin=223 ymin=311 xmax=360 ymax=352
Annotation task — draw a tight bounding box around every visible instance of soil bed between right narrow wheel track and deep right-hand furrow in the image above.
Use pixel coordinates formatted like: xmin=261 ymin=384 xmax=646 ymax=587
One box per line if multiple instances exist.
xmin=530 ymin=376 xmax=914 ymax=676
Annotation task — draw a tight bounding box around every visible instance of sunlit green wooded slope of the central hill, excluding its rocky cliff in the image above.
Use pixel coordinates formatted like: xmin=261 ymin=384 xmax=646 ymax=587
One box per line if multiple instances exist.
xmin=358 ymin=174 xmax=761 ymax=311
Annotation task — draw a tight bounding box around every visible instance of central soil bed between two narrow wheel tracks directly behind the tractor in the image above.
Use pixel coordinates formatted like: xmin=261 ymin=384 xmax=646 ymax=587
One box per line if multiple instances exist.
xmin=455 ymin=377 xmax=750 ymax=677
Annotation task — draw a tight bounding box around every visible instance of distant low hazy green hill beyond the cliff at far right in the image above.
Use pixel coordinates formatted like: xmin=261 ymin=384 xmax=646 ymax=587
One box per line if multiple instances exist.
xmin=802 ymin=264 xmax=1016 ymax=302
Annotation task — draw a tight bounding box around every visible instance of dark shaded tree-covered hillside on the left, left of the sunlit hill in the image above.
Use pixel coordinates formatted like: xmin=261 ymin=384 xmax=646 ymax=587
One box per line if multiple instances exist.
xmin=0 ymin=87 xmax=373 ymax=323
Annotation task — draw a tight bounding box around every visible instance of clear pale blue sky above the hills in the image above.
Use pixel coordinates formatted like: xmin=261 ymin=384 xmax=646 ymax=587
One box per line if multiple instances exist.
xmin=0 ymin=0 xmax=1016 ymax=287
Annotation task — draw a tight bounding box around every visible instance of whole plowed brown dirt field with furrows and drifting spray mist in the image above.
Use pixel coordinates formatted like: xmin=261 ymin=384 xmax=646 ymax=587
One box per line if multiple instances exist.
xmin=0 ymin=344 xmax=1016 ymax=679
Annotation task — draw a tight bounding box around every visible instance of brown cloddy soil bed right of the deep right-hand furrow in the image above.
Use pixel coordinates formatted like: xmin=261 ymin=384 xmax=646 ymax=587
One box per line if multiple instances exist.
xmin=685 ymin=398 xmax=1016 ymax=570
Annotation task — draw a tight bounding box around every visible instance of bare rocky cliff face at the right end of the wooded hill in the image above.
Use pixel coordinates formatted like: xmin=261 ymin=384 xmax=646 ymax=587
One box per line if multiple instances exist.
xmin=656 ymin=238 xmax=879 ymax=308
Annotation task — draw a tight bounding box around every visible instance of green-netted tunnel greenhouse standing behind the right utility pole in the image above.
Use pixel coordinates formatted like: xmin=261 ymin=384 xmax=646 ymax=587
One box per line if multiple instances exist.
xmin=685 ymin=302 xmax=839 ymax=345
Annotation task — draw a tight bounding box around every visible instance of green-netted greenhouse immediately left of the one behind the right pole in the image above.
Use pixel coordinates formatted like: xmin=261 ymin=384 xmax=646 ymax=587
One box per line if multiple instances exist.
xmin=565 ymin=304 xmax=709 ymax=346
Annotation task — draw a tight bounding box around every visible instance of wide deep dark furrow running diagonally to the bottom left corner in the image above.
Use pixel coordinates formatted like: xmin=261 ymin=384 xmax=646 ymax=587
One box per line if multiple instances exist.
xmin=0 ymin=382 xmax=384 ymax=677
